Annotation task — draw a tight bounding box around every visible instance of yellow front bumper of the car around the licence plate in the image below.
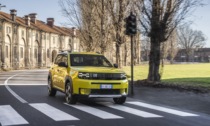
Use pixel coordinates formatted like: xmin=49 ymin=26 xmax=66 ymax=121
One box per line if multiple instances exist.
xmin=73 ymin=79 xmax=128 ymax=98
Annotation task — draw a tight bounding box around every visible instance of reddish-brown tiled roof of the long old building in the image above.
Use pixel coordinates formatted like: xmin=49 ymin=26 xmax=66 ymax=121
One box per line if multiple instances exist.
xmin=0 ymin=11 xmax=73 ymax=36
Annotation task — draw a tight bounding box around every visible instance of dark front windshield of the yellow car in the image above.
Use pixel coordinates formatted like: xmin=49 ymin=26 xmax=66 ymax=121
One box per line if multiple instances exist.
xmin=70 ymin=54 xmax=112 ymax=67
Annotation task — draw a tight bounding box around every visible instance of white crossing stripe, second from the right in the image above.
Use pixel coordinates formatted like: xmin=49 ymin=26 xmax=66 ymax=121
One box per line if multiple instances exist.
xmin=98 ymin=102 xmax=163 ymax=118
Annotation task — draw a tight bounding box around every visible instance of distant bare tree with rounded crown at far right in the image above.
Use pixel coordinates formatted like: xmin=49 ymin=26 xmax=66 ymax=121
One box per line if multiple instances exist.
xmin=178 ymin=26 xmax=206 ymax=62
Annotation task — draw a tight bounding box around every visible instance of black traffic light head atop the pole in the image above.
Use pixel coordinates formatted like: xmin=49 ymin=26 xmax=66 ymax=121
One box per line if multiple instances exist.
xmin=125 ymin=13 xmax=137 ymax=35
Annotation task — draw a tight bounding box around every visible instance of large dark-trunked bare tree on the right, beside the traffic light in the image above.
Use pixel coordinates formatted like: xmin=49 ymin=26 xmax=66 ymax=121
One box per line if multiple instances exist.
xmin=136 ymin=0 xmax=201 ymax=82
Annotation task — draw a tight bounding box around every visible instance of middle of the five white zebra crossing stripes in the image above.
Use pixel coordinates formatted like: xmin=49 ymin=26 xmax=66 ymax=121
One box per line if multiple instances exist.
xmin=64 ymin=103 xmax=123 ymax=119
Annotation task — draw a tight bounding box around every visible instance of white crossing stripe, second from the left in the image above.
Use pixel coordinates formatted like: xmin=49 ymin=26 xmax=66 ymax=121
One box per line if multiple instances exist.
xmin=30 ymin=103 xmax=79 ymax=121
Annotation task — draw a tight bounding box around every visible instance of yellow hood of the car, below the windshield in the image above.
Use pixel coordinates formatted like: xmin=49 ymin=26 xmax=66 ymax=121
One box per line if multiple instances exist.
xmin=71 ymin=67 xmax=124 ymax=73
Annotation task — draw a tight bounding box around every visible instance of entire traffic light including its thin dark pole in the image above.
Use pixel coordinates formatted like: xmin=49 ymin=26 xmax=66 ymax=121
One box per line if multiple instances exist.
xmin=125 ymin=12 xmax=137 ymax=95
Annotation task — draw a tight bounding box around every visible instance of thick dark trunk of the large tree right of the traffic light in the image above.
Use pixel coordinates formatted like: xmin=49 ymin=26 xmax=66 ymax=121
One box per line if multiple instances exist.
xmin=147 ymin=37 xmax=160 ymax=82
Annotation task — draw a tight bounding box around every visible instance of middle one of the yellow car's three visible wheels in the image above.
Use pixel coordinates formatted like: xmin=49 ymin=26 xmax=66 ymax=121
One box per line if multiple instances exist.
xmin=65 ymin=82 xmax=77 ymax=104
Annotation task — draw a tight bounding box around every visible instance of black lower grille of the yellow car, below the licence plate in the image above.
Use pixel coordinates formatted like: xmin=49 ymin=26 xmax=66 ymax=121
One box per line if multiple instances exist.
xmin=91 ymin=89 xmax=120 ymax=95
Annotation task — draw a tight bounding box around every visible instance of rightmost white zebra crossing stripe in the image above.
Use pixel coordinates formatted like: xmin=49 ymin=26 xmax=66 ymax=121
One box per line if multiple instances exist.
xmin=126 ymin=102 xmax=199 ymax=116
